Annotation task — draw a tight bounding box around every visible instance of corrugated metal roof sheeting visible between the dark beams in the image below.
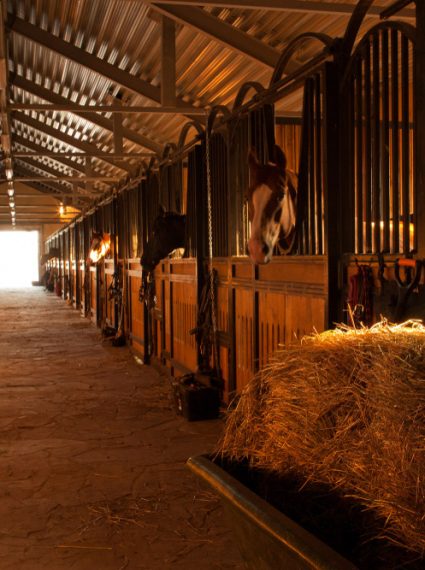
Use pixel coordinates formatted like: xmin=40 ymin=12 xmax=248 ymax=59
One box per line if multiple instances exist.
xmin=1 ymin=0 xmax=416 ymax=226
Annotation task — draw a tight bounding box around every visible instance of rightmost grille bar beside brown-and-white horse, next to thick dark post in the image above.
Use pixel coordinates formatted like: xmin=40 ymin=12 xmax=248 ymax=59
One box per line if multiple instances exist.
xmin=311 ymin=73 xmax=323 ymax=255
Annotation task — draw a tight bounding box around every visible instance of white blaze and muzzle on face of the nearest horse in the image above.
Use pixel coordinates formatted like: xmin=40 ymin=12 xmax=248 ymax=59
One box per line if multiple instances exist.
xmin=248 ymin=184 xmax=283 ymax=263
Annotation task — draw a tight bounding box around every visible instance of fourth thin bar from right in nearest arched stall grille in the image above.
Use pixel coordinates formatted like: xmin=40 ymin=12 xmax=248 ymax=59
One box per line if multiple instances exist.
xmin=371 ymin=32 xmax=381 ymax=252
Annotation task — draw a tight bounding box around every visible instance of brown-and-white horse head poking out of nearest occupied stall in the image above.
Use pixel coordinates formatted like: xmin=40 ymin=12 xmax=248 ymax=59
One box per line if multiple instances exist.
xmin=248 ymin=145 xmax=297 ymax=264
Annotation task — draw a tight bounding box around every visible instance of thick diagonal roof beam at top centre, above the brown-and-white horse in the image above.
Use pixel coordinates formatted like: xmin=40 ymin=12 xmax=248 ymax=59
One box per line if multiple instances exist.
xmin=151 ymin=3 xmax=280 ymax=68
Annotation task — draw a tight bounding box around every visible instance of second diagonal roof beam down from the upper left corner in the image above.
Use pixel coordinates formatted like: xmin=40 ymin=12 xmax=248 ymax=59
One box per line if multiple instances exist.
xmin=11 ymin=75 xmax=162 ymax=154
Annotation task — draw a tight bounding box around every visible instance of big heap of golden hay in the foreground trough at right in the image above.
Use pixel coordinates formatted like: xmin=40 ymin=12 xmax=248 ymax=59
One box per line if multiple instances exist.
xmin=219 ymin=321 xmax=425 ymax=556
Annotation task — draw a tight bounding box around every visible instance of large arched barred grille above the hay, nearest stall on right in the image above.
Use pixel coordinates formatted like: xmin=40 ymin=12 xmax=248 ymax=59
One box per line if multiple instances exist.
xmin=341 ymin=22 xmax=417 ymax=254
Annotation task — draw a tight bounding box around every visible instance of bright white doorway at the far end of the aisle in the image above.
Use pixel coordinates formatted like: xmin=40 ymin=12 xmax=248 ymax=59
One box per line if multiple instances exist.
xmin=0 ymin=231 xmax=39 ymax=289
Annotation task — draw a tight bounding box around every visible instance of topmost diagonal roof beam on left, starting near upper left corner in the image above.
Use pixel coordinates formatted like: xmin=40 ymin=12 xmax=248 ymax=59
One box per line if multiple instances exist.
xmin=8 ymin=15 xmax=198 ymax=113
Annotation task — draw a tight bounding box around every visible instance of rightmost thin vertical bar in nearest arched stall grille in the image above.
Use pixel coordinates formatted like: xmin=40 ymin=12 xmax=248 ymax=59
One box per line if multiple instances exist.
xmin=401 ymin=32 xmax=410 ymax=254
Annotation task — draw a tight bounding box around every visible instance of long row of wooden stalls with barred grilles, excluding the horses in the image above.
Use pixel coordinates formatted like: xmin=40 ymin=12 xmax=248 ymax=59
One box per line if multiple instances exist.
xmin=43 ymin=3 xmax=424 ymax=402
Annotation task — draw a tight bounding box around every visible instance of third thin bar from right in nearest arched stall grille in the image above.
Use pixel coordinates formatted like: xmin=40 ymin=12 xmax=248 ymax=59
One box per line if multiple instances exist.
xmin=381 ymin=30 xmax=390 ymax=252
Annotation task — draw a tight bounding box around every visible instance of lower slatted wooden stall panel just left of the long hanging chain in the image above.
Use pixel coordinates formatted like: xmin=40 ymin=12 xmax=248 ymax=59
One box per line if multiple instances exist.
xmin=172 ymin=282 xmax=197 ymax=370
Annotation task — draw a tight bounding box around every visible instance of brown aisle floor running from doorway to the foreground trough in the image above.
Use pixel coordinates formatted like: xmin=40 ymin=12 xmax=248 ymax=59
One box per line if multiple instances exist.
xmin=0 ymin=289 xmax=244 ymax=570
